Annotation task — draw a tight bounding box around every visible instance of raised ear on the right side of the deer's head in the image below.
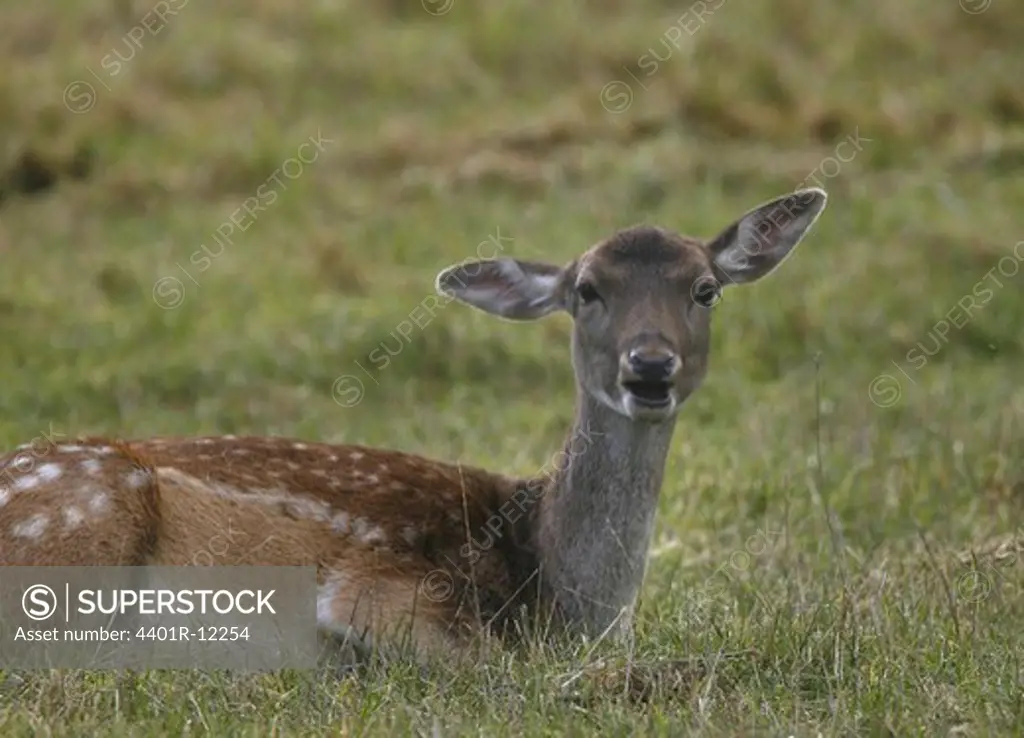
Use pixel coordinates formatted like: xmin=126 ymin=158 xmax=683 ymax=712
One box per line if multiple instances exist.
xmin=708 ymin=187 xmax=828 ymax=285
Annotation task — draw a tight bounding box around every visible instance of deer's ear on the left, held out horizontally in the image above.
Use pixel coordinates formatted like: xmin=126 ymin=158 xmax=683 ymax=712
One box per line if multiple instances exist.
xmin=436 ymin=258 xmax=564 ymax=320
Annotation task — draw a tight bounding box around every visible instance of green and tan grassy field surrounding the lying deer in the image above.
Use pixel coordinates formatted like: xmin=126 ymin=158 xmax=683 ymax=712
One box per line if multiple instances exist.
xmin=0 ymin=0 xmax=1024 ymax=736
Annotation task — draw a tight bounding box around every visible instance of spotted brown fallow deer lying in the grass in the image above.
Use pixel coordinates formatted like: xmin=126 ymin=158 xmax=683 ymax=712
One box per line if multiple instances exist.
xmin=0 ymin=188 xmax=827 ymax=659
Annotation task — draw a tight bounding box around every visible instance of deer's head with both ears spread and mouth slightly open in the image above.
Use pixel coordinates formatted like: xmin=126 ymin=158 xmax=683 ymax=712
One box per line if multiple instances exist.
xmin=436 ymin=188 xmax=827 ymax=422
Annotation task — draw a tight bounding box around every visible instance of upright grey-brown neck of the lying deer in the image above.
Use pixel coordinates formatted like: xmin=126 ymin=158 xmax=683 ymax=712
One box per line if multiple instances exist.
xmin=536 ymin=391 xmax=675 ymax=634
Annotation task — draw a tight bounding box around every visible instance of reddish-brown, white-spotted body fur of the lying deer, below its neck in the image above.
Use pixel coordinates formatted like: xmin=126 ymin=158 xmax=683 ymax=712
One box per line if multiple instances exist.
xmin=0 ymin=437 xmax=548 ymax=646
